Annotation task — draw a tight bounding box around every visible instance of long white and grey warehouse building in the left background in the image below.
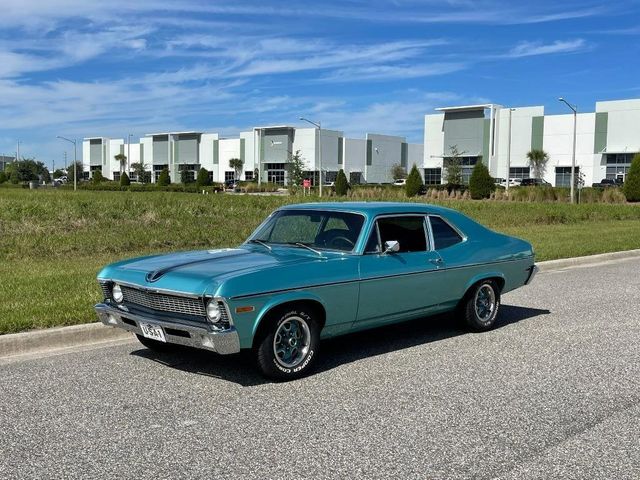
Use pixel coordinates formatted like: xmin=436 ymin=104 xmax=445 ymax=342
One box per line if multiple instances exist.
xmin=82 ymin=125 xmax=424 ymax=185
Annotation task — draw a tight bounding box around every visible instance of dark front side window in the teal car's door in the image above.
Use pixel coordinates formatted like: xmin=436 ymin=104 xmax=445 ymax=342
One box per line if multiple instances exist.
xmin=365 ymin=215 xmax=427 ymax=253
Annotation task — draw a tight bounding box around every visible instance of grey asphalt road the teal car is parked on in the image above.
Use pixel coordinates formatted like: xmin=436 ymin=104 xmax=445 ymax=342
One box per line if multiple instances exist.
xmin=0 ymin=259 xmax=640 ymax=480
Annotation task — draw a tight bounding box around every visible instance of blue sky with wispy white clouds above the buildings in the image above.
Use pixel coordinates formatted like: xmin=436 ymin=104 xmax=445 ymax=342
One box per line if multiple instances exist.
xmin=0 ymin=0 xmax=640 ymax=169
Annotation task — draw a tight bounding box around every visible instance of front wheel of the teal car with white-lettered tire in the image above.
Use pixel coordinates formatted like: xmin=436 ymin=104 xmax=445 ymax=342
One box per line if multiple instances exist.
xmin=255 ymin=307 xmax=320 ymax=380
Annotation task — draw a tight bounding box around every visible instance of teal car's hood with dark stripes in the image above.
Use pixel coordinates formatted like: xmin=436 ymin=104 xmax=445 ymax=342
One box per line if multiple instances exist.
xmin=98 ymin=246 xmax=326 ymax=295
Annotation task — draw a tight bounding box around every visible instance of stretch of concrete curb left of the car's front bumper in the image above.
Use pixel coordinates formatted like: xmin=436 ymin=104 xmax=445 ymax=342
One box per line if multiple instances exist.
xmin=0 ymin=322 xmax=132 ymax=358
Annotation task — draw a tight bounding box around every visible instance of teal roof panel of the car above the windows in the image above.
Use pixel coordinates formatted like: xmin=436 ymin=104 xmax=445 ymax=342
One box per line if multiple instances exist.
xmin=279 ymin=202 xmax=452 ymax=216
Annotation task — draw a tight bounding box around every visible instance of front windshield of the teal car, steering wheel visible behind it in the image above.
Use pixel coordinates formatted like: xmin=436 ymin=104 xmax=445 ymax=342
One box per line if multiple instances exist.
xmin=249 ymin=210 xmax=364 ymax=252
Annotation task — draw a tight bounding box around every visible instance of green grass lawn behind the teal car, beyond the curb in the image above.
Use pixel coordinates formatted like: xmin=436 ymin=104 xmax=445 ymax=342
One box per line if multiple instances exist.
xmin=0 ymin=188 xmax=640 ymax=334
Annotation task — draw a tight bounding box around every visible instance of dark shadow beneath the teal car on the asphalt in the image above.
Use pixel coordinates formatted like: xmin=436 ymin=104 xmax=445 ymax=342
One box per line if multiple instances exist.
xmin=131 ymin=305 xmax=551 ymax=387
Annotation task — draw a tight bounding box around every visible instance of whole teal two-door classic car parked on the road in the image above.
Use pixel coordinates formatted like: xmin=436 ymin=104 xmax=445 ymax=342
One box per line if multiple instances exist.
xmin=95 ymin=202 xmax=537 ymax=379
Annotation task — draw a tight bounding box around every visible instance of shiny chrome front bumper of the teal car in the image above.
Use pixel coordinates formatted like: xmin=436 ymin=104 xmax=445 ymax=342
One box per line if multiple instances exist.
xmin=95 ymin=303 xmax=240 ymax=355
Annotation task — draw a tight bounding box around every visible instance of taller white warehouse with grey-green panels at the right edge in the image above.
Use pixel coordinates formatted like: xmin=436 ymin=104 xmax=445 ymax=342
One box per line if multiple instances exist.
xmin=424 ymin=99 xmax=640 ymax=186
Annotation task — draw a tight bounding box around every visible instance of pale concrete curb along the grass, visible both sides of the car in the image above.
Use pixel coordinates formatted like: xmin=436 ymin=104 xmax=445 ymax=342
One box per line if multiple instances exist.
xmin=0 ymin=249 xmax=640 ymax=358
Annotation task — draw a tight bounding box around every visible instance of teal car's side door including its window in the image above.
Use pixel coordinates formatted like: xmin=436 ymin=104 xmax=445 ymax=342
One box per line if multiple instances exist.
xmin=356 ymin=214 xmax=446 ymax=328
